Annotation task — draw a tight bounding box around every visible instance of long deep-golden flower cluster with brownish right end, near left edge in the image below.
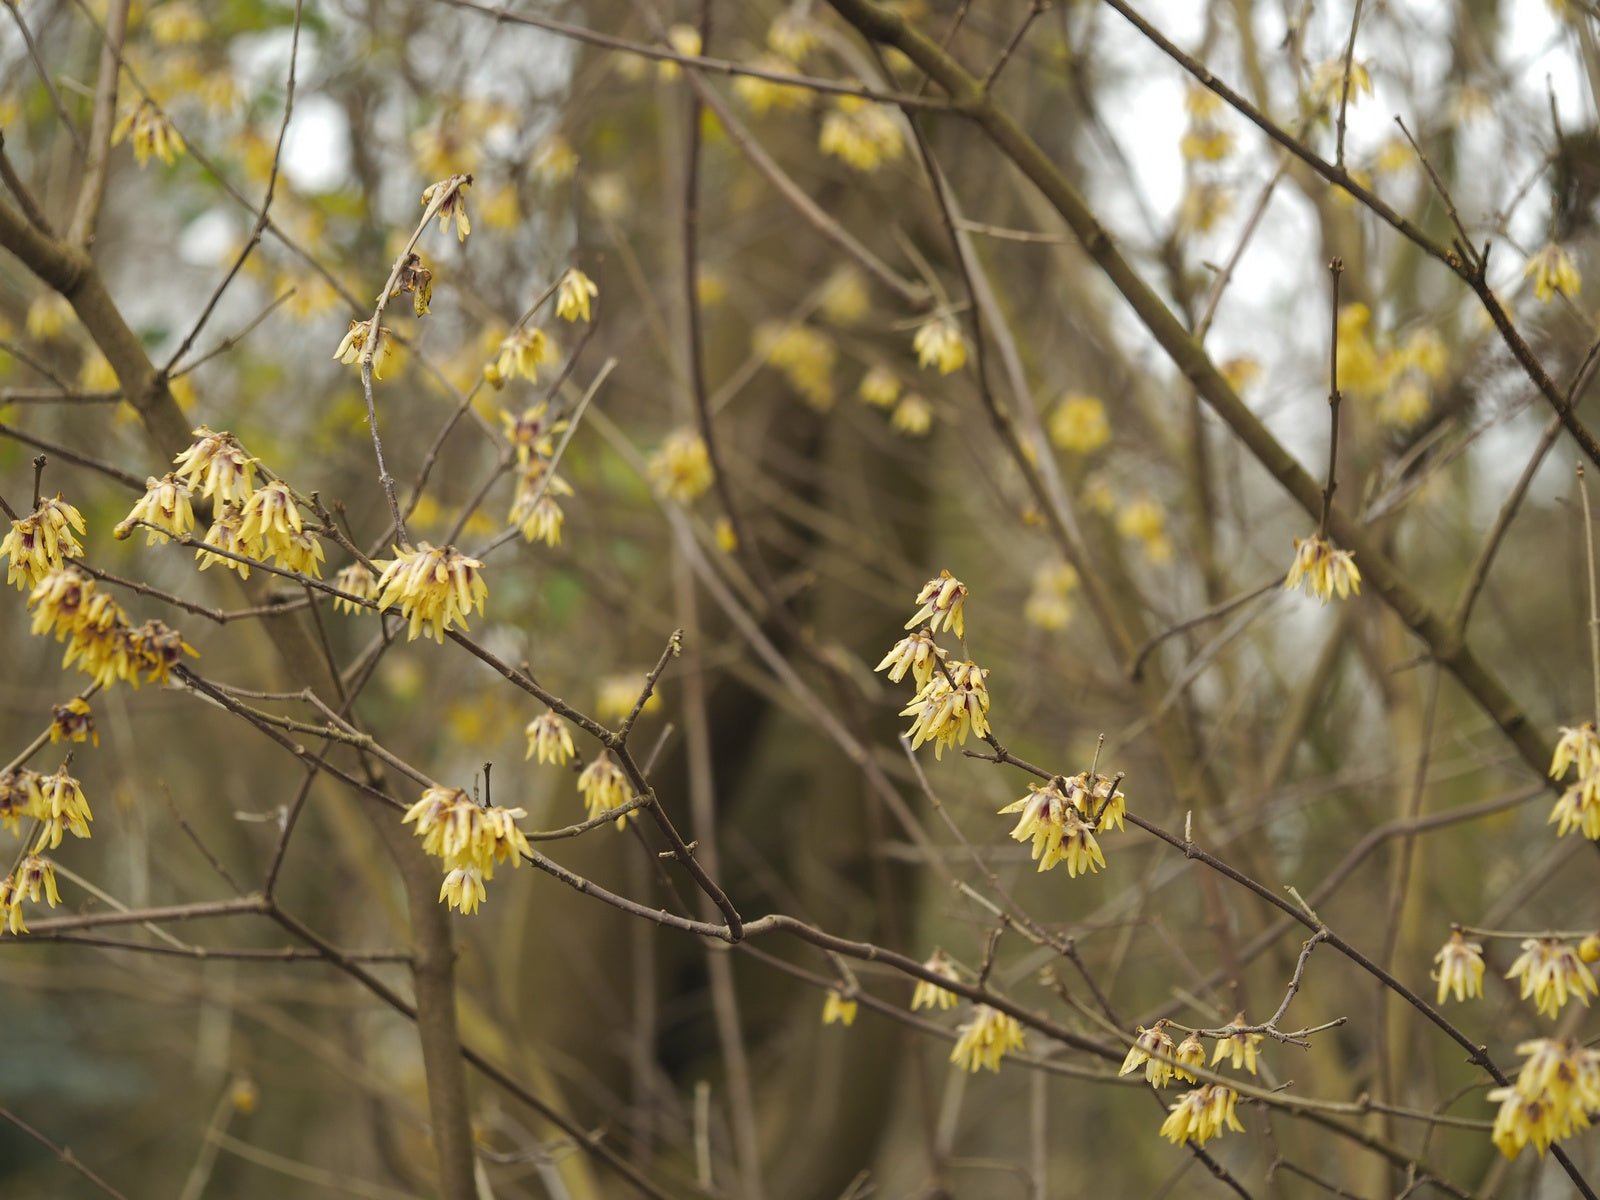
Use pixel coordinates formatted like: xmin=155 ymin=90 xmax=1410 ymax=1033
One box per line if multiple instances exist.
xmin=27 ymin=566 xmax=195 ymax=688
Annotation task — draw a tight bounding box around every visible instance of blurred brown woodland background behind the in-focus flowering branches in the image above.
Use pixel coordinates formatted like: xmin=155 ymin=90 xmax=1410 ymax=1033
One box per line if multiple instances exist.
xmin=0 ymin=0 xmax=1600 ymax=1200
